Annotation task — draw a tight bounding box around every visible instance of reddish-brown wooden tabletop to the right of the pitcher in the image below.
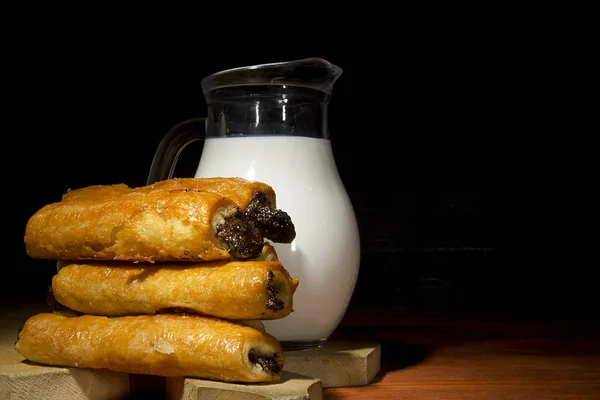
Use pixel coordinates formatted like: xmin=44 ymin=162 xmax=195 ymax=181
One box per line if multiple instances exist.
xmin=324 ymin=311 xmax=600 ymax=400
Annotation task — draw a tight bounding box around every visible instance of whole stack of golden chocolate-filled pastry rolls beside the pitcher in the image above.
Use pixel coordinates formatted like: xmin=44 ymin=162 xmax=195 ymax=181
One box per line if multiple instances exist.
xmin=15 ymin=178 xmax=298 ymax=382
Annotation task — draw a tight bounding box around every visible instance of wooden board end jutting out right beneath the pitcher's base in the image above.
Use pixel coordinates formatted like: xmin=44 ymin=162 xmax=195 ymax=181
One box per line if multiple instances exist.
xmin=285 ymin=340 xmax=381 ymax=388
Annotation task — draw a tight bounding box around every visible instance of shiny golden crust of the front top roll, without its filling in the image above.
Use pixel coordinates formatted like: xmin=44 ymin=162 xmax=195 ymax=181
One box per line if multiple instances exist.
xmin=25 ymin=190 xmax=237 ymax=262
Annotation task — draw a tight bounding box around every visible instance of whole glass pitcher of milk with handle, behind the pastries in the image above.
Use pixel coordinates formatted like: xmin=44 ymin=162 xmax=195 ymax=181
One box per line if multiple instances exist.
xmin=148 ymin=58 xmax=360 ymax=350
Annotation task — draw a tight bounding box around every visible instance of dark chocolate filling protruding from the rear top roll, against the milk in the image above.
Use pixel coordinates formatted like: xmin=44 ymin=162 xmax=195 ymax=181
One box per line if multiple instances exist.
xmin=244 ymin=192 xmax=296 ymax=243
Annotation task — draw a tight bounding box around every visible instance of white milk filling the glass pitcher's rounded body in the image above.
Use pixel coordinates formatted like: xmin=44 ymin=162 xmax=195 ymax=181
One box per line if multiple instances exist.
xmin=196 ymin=136 xmax=360 ymax=342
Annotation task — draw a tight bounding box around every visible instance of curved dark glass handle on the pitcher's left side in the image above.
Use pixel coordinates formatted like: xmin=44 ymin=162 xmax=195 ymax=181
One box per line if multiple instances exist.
xmin=146 ymin=118 xmax=206 ymax=185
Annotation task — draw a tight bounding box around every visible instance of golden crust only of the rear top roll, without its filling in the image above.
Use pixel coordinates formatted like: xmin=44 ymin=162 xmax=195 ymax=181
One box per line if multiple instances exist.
xmin=62 ymin=178 xmax=276 ymax=210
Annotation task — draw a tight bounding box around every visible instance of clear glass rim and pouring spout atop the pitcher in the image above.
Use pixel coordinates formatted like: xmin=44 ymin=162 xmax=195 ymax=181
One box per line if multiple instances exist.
xmin=201 ymin=57 xmax=342 ymax=96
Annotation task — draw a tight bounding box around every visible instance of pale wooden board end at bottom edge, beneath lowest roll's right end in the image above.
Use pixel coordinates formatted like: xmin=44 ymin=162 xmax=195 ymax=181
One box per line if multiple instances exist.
xmin=167 ymin=372 xmax=323 ymax=400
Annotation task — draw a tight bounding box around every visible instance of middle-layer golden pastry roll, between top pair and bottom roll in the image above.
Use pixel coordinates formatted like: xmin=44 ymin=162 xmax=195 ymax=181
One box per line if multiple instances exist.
xmin=52 ymin=261 xmax=298 ymax=320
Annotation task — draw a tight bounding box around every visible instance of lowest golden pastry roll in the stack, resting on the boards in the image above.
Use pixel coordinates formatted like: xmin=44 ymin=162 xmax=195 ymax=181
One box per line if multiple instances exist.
xmin=15 ymin=313 xmax=284 ymax=382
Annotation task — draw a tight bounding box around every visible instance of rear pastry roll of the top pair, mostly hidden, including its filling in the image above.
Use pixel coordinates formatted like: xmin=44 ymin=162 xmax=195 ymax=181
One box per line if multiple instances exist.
xmin=62 ymin=178 xmax=296 ymax=243
